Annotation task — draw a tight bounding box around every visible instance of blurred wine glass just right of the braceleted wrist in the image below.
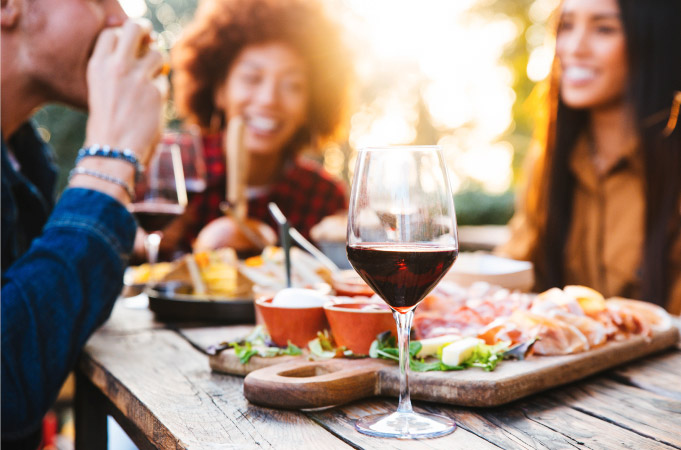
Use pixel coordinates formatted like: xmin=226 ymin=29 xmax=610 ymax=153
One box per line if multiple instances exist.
xmin=128 ymin=141 xmax=187 ymax=270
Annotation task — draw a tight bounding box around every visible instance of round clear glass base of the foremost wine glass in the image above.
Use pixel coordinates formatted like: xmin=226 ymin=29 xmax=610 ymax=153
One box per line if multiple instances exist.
xmin=355 ymin=412 xmax=456 ymax=439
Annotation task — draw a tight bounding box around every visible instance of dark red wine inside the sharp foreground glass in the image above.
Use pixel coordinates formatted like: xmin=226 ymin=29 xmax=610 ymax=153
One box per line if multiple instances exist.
xmin=347 ymin=242 xmax=459 ymax=313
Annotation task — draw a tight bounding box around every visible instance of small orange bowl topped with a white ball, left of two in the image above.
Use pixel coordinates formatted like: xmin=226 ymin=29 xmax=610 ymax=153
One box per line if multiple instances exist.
xmin=255 ymin=297 xmax=329 ymax=348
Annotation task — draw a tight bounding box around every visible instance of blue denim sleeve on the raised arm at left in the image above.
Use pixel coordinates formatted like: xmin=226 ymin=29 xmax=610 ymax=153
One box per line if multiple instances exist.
xmin=2 ymin=188 xmax=136 ymax=439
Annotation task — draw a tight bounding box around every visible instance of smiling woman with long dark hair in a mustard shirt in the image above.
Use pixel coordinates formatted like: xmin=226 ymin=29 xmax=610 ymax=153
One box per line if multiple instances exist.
xmin=500 ymin=0 xmax=681 ymax=314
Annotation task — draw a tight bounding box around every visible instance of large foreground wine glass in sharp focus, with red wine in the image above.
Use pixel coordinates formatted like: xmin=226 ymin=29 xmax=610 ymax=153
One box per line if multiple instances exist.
xmin=347 ymin=146 xmax=459 ymax=438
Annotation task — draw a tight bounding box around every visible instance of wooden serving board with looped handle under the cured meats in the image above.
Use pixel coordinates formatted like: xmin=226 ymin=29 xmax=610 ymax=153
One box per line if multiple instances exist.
xmin=210 ymin=326 xmax=679 ymax=409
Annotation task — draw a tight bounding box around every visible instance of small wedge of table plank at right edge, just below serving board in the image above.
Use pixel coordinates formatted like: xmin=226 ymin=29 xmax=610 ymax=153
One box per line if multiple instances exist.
xmin=612 ymin=350 xmax=681 ymax=400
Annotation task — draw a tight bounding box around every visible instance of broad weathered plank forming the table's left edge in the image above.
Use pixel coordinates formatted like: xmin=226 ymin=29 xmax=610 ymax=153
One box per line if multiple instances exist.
xmin=80 ymin=330 xmax=348 ymax=449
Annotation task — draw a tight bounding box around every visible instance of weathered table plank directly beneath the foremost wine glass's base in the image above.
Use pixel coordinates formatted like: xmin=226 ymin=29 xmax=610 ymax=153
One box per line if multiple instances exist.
xmin=307 ymin=399 xmax=498 ymax=450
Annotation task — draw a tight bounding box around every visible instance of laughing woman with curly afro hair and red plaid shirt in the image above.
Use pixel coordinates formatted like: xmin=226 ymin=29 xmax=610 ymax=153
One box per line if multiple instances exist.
xmin=161 ymin=0 xmax=352 ymax=255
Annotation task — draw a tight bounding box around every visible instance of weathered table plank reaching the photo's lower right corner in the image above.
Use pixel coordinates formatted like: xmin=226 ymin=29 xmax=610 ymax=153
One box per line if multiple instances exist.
xmin=549 ymin=379 xmax=681 ymax=448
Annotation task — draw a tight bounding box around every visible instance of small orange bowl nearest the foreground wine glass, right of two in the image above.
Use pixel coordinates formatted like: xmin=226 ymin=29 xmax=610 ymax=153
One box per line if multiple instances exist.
xmin=324 ymin=302 xmax=397 ymax=355
